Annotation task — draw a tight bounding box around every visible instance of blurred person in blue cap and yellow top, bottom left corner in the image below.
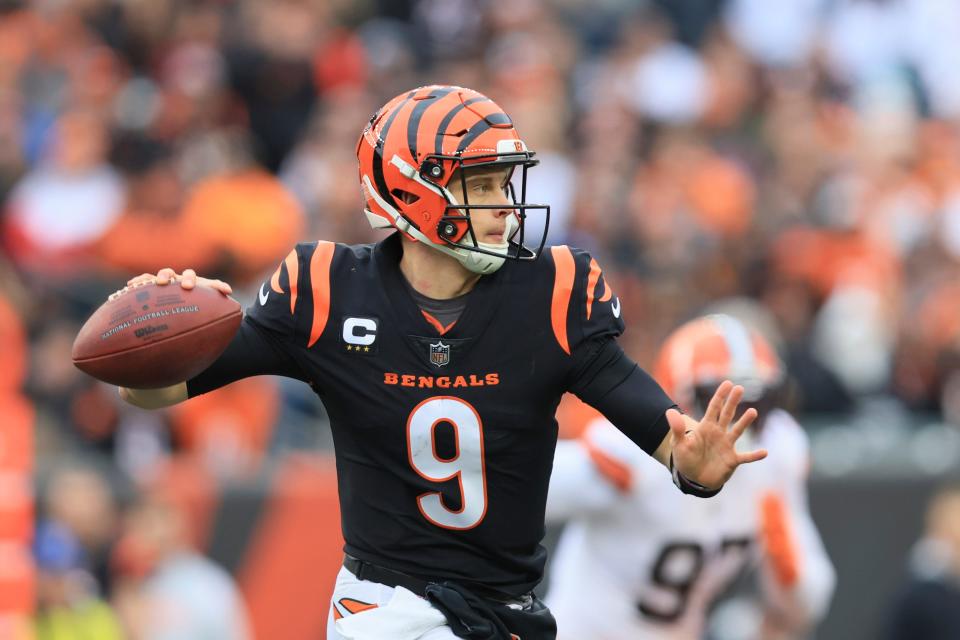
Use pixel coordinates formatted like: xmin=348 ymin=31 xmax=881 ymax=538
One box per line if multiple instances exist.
xmin=33 ymin=522 xmax=124 ymax=640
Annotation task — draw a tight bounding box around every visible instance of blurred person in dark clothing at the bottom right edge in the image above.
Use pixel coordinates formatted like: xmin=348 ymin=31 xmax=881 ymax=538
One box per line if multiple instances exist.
xmin=884 ymin=486 xmax=960 ymax=640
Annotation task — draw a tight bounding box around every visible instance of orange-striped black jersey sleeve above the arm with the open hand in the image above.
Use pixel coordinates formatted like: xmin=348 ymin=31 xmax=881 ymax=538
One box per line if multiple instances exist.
xmin=550 ymin=246 xmax=624 ymax=355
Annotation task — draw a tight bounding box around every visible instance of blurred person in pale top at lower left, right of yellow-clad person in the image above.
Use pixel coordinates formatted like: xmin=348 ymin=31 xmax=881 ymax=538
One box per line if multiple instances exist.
xmin=113 ymin=492 xmax=250 ymax=640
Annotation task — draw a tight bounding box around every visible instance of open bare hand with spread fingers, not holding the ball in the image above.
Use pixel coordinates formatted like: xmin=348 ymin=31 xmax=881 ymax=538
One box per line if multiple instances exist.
xmin=667 ymin=380 xmax=767 ymax=488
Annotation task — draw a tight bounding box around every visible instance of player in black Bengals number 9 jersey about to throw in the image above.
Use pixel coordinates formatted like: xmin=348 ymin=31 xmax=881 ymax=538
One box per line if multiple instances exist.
xmin=121 ymin=86 xmax=766 ymax=640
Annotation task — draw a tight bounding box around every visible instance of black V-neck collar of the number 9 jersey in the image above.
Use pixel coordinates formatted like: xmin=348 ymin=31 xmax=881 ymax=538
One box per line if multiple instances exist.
xmin=373 ymin=233 xmax=508 ymax=338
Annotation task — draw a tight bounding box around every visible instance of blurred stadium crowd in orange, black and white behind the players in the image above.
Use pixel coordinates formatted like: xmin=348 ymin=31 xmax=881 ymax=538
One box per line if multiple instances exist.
xmin=0 ymin=0 xmax=960 ymax=639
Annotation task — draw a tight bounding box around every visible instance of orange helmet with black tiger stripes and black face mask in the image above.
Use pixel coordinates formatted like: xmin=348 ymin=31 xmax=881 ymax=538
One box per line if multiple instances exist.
xmin=357 ymin=85 xmax=550 ymax=274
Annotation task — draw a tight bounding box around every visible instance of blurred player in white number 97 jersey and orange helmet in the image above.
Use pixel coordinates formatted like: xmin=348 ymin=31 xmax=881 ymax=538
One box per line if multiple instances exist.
xmin=547 ymin=315 xmax=836 ymax=640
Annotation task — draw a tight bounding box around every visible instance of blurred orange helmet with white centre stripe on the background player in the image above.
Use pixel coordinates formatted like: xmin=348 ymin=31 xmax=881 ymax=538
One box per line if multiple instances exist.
xmin=653 ymin=314 xmax=785 ymax=415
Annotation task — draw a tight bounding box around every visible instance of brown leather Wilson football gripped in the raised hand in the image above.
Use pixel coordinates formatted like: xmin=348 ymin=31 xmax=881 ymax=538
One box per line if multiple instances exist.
xmin=73 ymin=283 xmax=243 ymax=389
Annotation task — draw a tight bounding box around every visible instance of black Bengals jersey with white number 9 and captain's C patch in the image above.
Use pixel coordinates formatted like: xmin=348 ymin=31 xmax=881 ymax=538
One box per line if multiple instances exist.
xmin=188 ymin=234 xmax=671 ymax=595
